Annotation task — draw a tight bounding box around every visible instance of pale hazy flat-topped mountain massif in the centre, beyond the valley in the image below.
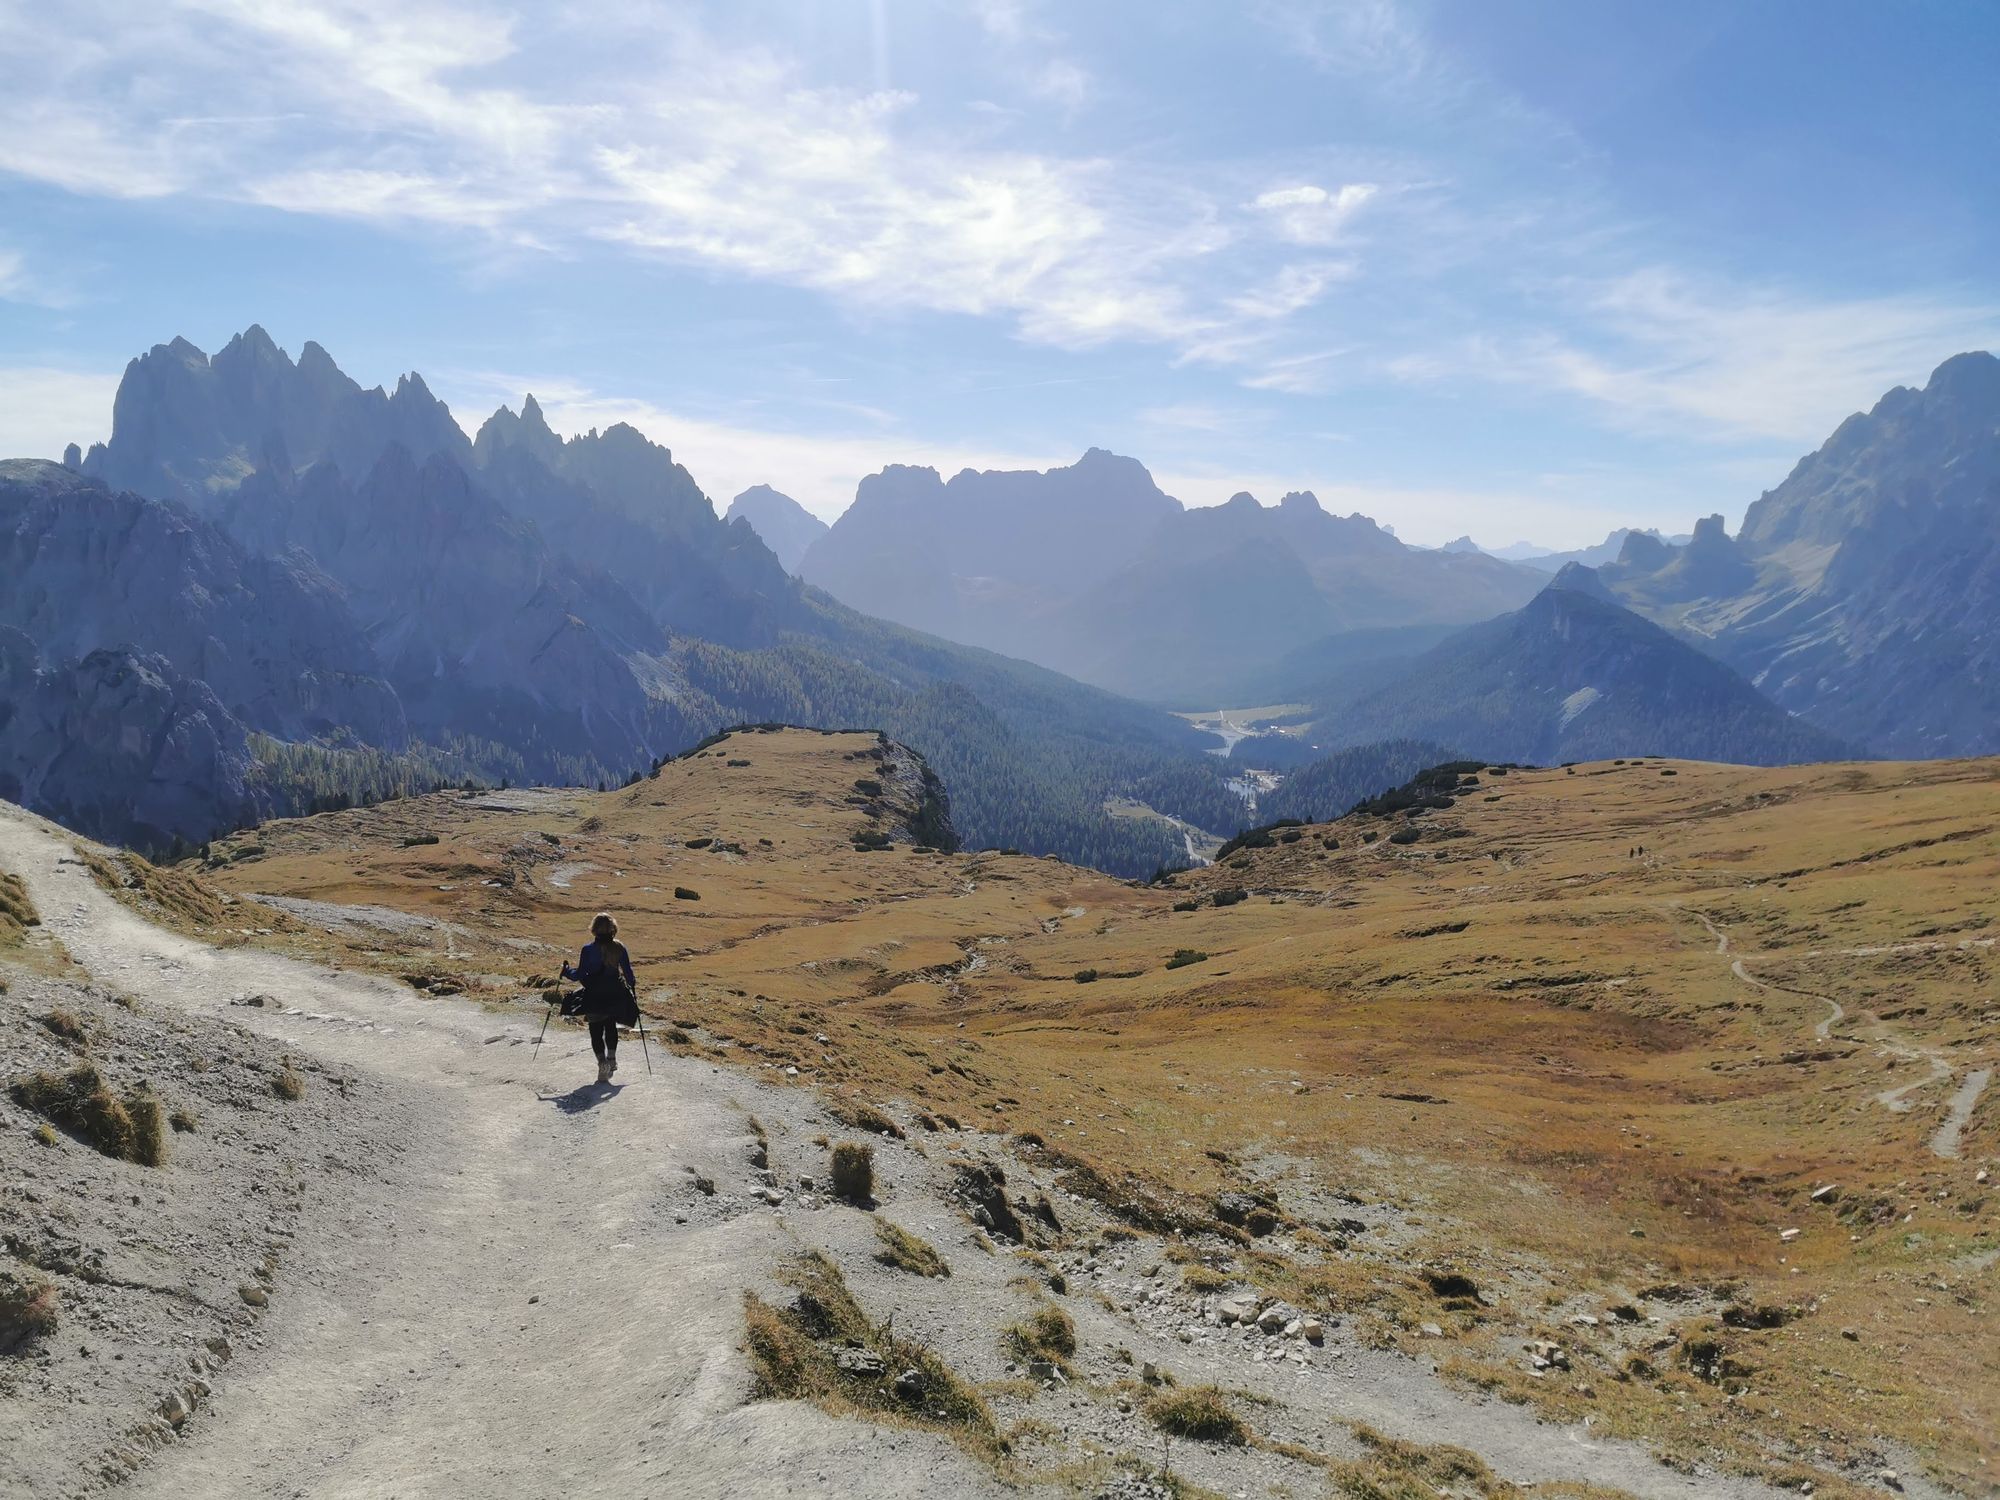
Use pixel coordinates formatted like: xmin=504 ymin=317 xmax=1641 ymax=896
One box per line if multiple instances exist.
xmin=800 ymin=464 xmax=1540 ymax=706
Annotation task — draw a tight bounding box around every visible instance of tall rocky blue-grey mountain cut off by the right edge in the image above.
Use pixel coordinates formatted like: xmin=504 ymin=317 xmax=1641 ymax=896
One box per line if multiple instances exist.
xmin=1602 ymin=354 xmax=2000 ymax=756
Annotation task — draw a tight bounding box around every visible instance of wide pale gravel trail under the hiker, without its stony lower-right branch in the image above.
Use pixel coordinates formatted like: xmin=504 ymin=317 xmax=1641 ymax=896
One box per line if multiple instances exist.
xmin=0 ymin=814 xmax=1002 ymax=1500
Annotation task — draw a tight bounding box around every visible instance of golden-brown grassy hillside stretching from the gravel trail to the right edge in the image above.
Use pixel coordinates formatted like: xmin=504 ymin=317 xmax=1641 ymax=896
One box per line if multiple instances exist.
xmin=180 ymin=732 xmax=2000 ymax=1494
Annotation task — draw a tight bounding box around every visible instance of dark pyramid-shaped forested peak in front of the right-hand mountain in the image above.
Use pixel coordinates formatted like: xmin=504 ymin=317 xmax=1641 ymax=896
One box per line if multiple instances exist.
xmin=1314 ymin=564 xmax=1844 ymax=764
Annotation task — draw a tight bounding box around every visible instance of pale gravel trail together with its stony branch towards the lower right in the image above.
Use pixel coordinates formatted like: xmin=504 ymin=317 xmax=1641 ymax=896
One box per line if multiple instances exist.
xmin=0 ymin=810 xmax=1824 ymax=1500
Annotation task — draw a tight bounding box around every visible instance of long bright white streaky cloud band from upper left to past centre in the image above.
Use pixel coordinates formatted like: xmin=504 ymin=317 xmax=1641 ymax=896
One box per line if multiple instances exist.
xmin=0 ymin=0 xmax=1356 ymax=372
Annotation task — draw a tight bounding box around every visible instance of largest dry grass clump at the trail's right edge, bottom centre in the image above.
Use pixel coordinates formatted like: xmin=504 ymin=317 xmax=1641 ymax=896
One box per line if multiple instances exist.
xmin=744 ymin=1250 xmax=1008 ymax=1462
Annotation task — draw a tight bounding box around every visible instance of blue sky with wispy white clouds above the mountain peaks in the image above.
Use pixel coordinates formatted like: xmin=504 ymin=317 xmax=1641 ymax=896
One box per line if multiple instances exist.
xmin=0 ymin=0 xmax=2000 ymax=544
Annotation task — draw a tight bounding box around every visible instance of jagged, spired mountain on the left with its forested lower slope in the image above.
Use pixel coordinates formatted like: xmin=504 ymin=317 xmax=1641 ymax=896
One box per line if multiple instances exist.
xmin=31 ymin=328 xmax=1242 ymax=874
